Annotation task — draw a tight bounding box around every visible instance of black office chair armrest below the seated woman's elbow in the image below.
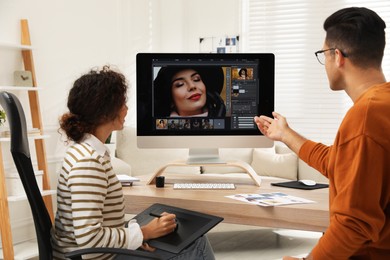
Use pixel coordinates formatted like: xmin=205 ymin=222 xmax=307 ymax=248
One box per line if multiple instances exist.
xmin=65 ymin=247 xmax=161 ymax=260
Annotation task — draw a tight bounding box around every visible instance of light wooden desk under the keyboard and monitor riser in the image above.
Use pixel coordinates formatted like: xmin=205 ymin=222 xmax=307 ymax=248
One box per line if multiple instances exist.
xmin=123 ymin=174 xmax=329 ymax=232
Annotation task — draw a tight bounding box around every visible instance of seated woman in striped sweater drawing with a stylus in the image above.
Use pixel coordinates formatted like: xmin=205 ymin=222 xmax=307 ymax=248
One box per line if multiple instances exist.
xmin=52 ymin=66 xmax=214 ymax=259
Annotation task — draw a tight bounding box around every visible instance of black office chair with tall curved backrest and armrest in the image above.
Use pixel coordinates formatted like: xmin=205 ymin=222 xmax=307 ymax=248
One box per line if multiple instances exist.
xmin=0 ymin=91 xmax=160 ymax=260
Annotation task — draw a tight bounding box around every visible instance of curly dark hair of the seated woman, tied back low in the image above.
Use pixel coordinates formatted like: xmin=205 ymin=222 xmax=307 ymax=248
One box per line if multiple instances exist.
xmin=59 ymin=66 xmax=128 ymax=142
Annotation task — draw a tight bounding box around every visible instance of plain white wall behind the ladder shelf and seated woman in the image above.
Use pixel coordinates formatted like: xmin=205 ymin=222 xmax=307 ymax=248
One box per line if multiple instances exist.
xmin=0 ymin=0 xmax=240 ymax=249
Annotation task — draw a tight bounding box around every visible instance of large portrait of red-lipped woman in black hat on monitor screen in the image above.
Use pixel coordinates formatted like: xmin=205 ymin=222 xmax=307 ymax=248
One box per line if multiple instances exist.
xmin=154 ymin=66 xmax=226 ymax=117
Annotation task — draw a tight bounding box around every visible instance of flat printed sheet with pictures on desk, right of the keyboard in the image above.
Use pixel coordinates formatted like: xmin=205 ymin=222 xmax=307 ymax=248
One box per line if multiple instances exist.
xmin=226 ymin=192 xmax=315 ymax=207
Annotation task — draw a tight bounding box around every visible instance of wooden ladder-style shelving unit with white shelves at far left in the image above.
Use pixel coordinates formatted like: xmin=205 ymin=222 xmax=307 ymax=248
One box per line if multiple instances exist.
xmin=0 ymin=20 xmax=56 ymax=259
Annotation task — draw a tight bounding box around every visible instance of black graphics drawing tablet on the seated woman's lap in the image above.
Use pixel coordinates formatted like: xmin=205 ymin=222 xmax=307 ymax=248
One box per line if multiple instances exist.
xmin=134 ymin=203 xmax=223 ymax=253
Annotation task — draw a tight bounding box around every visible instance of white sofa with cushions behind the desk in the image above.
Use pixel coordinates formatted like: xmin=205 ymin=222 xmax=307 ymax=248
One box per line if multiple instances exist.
xmin=113 ymin=127 xmax=328 ymax=183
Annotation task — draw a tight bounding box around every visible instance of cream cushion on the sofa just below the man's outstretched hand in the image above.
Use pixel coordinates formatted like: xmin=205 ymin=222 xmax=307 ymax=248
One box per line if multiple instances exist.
xmin=252 ymin=149 xmax=298 ymax=180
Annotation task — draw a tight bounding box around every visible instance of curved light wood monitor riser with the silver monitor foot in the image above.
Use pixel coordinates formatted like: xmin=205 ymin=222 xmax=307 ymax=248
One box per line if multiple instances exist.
xmin=147 ymin=149 xmax=261 ymax=187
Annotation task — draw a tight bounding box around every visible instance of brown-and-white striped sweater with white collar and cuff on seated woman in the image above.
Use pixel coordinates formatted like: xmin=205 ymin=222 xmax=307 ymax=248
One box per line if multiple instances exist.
xmin=52 ymin=135 xmax=142 ymax=259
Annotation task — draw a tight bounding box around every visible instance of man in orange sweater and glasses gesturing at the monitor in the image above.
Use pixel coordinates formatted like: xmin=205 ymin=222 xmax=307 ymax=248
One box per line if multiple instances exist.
xmin=255 ymin=7 xmax=390 ymax=260
